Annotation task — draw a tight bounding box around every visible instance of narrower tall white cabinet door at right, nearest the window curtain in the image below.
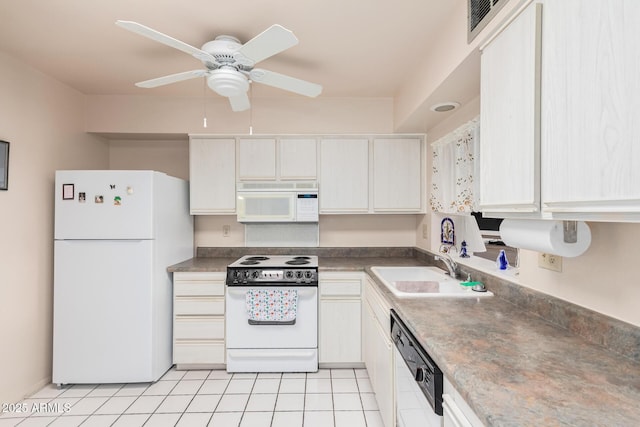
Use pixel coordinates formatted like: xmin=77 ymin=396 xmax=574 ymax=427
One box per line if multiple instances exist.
xmin=480 ymin=4 xmax=540 ymax=213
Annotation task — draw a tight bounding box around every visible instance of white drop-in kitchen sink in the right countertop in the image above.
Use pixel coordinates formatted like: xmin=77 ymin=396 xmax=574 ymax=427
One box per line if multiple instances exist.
xmin=371 ymin=267 xmax=493 ymax=298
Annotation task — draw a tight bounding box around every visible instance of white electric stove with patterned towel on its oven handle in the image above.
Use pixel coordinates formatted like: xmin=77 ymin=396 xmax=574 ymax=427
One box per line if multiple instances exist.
xmin=226 ymin=255 xmax=318 ymax=372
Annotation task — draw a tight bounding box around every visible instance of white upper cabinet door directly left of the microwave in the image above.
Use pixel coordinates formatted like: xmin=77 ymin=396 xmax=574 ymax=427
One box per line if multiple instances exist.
xmin=189 ymin=138 xmax=236 ymax=215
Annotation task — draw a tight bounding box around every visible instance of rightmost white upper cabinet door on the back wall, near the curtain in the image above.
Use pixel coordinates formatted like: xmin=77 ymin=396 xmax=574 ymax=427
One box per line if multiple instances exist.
xmin=373 ymin=138 xmax=423 ymax=212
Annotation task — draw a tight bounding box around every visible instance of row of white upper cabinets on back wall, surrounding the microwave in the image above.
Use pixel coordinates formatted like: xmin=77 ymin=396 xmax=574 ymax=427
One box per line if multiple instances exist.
xmin=189 ymin=135 xmax=426 ymax=215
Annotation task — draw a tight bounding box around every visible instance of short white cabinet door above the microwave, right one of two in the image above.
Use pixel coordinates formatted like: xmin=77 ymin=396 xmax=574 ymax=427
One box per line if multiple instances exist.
xmin=278 ymin=138 xmax=317 ymax=180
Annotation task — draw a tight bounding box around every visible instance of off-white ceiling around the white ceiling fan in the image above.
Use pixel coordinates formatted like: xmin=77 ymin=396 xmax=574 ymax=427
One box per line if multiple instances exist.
xmin=0 ymin=0 xmax=465 ymax=97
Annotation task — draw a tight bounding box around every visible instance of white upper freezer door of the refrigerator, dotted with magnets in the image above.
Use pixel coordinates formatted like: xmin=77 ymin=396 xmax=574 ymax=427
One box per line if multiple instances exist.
xmin=55 ymin=171 xmax=154 ymax=239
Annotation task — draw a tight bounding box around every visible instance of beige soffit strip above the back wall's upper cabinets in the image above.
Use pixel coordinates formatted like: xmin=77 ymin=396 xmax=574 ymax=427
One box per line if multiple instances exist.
xmin=87 ymin=95 xmax=393 ymax=135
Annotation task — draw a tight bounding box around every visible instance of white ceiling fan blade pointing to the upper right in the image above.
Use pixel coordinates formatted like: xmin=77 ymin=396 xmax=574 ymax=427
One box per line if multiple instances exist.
xmin=234 ymin=24 xmax=298 ymax=66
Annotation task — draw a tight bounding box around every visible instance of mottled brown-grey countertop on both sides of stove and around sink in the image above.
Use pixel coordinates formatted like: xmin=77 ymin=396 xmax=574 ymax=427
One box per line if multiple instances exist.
xmin=169 ymin=257 xmax=640 ymax=427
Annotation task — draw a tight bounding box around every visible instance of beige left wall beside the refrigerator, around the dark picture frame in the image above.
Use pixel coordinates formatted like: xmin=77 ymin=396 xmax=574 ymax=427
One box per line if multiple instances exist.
xmin=0 ymin=53 xmax=108 ymax=403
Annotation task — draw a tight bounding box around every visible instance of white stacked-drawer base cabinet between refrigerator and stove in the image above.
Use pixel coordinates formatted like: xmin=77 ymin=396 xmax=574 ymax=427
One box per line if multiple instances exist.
xmin=173 ymin=272 xmax=225 ymax=369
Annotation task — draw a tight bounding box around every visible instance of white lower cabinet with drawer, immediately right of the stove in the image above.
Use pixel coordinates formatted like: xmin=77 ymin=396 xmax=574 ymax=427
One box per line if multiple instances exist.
xmin=318 ymin=272 xmax=364 ymax=367
